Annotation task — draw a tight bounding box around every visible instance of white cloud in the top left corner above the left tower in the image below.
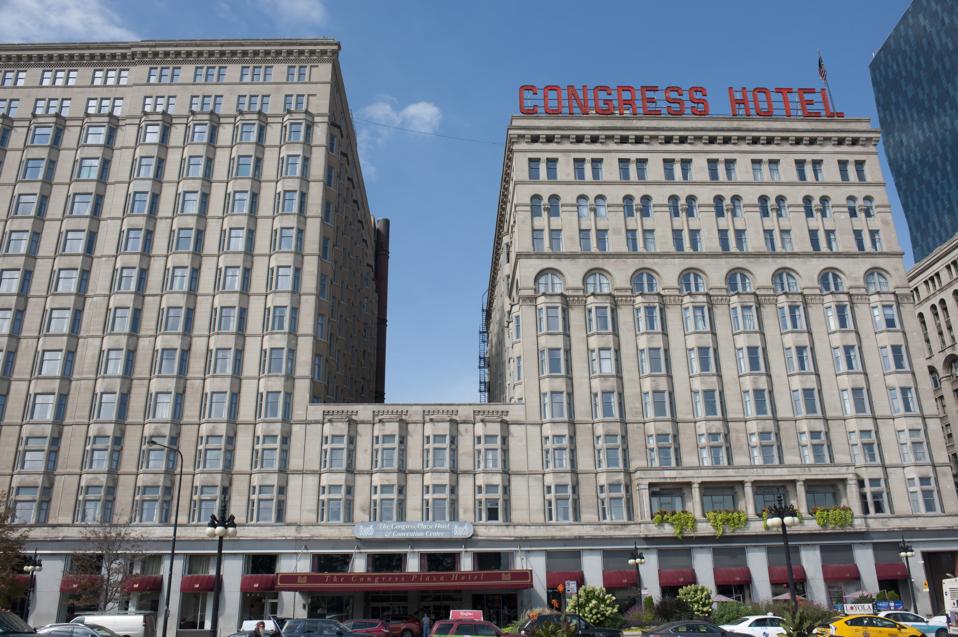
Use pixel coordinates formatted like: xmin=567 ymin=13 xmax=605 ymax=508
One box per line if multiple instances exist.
xmin=0 ymin=0 xmax=139 ymax=42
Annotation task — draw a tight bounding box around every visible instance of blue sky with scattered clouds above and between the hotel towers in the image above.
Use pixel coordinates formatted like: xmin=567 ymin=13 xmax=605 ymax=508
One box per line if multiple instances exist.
xmin=0 ymin=0 xmax=911 ymax=402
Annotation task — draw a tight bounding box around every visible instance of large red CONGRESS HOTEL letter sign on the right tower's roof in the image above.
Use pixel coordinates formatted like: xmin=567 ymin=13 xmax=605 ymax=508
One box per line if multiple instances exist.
xmin=519 ymin=84 xmax=845 ymax=118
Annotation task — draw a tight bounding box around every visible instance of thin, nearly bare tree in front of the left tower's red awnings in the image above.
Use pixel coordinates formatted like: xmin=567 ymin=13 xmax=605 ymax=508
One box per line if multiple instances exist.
xmin=70 ymin=523 xmax=142 ymax=611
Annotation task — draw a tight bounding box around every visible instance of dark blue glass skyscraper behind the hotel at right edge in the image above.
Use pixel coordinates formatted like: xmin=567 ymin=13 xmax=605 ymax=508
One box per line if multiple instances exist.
xmin=870 ymin=0 xmax=958 ymax=261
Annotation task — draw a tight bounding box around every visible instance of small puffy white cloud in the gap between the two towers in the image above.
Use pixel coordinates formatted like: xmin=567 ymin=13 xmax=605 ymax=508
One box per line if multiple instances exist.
xmin=358 ymin=95 xmax=442 ymax=177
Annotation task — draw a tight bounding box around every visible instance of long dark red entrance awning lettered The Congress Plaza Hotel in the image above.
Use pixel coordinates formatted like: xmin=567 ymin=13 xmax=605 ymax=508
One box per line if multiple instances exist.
xmin=276 ymin=570 xmax=532 ymax=593
